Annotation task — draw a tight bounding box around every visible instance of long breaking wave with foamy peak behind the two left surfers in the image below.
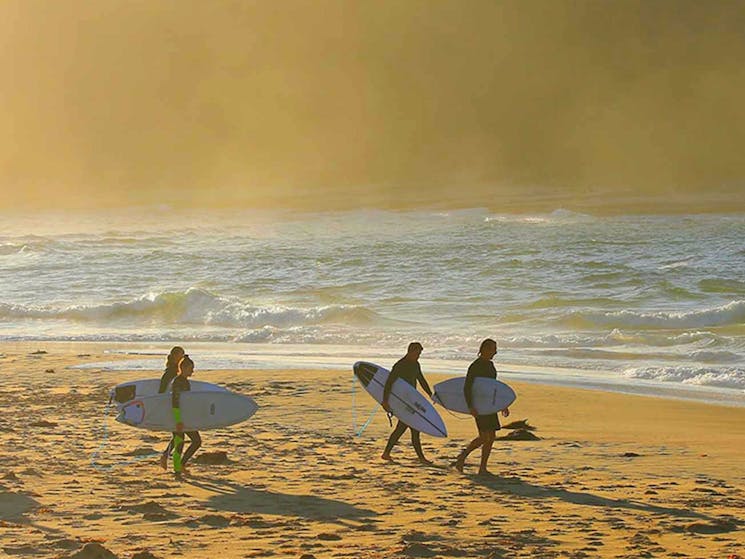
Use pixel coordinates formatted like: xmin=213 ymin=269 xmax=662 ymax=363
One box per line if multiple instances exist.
xmin=0 ymin=288 xmax=386 ymax=328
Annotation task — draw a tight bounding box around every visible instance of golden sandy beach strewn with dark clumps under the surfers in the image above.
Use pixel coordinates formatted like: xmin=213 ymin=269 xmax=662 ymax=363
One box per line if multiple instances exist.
xmin=0 ymin=342 xmax=745 ymax=559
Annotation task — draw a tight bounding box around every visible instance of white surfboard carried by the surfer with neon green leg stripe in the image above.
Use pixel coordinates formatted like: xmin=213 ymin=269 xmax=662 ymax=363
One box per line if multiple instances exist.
xmin=116 ymin=390 xmax=259 ymax=431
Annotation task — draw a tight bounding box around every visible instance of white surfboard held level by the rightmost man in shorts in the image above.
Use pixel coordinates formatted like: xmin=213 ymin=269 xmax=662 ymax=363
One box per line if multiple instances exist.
xmin=432 ymin=377 xmax=517 ymax=415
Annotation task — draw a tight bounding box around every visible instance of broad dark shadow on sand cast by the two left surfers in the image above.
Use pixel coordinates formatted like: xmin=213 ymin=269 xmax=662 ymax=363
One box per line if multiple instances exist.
xmin=187 ymin=478 xmax=378 ymax=521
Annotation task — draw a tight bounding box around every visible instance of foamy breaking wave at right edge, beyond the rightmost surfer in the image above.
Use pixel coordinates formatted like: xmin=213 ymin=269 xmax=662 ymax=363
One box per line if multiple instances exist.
xmin=560 ymin=300 xmax=745 ymax=329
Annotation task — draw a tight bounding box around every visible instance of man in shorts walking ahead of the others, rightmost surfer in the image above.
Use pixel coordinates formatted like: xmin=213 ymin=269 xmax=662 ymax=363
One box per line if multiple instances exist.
xmin=453 ymin=338 xmax=510 ymax=476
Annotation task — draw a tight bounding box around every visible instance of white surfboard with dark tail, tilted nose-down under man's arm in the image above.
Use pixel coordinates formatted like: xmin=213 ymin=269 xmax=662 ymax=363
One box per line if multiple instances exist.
xmin=353 ymin=361 xmax=448 ymax=437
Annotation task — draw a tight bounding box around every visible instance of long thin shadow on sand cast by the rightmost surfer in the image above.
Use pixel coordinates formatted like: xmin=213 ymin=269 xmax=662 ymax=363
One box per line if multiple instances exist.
xmin=469 ymin=476 xmax=714 ymax=520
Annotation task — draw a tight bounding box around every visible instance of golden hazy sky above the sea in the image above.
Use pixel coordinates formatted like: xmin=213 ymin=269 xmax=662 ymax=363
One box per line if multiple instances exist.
xmin=0 ymin=0 xmax=745 ymax=207
